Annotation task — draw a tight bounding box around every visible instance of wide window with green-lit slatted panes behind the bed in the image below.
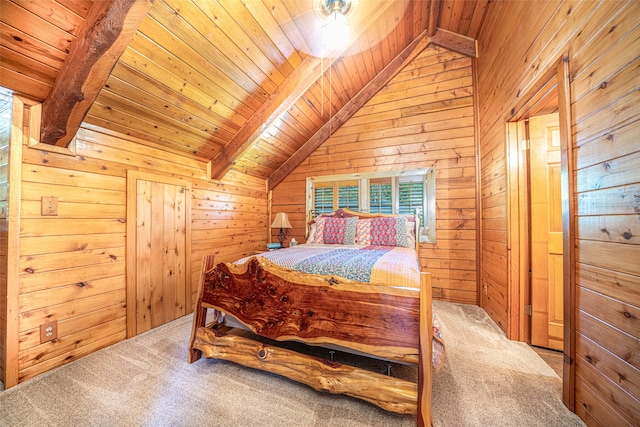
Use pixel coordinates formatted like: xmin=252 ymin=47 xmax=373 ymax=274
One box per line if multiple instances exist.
xmin=307 ymin=168 xmax=436 ymax=243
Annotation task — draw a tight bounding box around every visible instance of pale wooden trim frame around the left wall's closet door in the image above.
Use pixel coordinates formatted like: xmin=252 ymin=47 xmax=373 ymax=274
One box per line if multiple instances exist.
xmin=126 ymin=170 xmax=193 ymax=338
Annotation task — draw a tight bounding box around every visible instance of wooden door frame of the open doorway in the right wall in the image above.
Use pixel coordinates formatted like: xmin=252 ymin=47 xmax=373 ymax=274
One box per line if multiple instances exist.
xmin=506 ymin=53 xmax=576 ymax=411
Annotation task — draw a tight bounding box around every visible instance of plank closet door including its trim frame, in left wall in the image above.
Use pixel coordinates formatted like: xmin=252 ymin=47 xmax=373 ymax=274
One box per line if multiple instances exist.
xmin=127 ymin=173 xmax=191 ymax=336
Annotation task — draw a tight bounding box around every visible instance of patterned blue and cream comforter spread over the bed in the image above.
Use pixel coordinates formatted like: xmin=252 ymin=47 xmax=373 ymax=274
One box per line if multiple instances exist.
xmin=236 ymin=244 xmax=420 ymax=288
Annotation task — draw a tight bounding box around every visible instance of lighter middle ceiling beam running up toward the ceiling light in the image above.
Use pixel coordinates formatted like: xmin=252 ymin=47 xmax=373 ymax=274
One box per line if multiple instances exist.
xmin=209 ymin=0 xmax=386 ymax=180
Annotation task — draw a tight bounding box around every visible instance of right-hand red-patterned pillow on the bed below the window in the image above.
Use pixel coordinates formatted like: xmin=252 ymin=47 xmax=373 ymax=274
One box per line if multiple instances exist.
xmin=356 ymin=217 xmax=409 ymax=248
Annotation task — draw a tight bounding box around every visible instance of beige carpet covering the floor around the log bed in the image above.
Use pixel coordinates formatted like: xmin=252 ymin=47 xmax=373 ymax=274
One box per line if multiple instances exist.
xmin=0 ymin=302 xmax=582 ymax=427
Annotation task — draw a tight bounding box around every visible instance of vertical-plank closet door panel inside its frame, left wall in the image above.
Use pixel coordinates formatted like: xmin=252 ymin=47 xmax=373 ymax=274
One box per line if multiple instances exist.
xmin=135 ymin=179 xmax=188 ymax=334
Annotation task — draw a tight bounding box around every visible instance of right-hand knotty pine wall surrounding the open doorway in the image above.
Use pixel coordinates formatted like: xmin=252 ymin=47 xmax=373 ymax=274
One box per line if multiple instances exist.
xmin=477 ymin=1 xmax=640 ymax=426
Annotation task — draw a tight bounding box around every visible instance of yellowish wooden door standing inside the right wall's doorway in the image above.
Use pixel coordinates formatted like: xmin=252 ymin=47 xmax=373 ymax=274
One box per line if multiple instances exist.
xmin=529 ymin=113 xmax=564 ymax=350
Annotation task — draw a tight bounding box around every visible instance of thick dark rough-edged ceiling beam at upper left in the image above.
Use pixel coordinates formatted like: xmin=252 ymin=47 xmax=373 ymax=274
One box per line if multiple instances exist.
xmin=40 ymin=0 xmax=154 ymax=147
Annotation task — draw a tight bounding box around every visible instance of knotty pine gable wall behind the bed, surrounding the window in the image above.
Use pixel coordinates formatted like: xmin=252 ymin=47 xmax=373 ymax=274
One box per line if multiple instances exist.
xmin=272 ymin=47 xmax=477 ymax=304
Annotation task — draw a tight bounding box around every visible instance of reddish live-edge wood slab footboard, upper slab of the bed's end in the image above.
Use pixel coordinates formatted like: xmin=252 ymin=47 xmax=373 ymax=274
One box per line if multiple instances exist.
xmin=202 ymin=257 xmax=420 ymax=363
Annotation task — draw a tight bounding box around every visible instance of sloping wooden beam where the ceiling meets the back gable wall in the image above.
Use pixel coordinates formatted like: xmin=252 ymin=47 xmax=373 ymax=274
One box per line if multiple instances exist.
xmin=267 ymin=30 xmax=430 ymax=191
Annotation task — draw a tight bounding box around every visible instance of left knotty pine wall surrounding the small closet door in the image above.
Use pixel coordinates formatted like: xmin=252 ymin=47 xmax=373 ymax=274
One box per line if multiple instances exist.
xmin=8 ymin=105 xmax=267 ymax=382
